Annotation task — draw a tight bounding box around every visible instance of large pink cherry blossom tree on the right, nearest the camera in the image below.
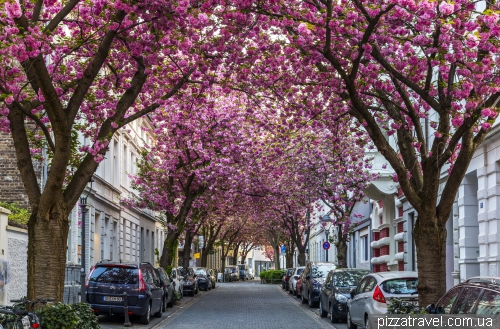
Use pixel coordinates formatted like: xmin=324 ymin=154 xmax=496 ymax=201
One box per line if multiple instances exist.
xmin=233 ymin=0 xmax=500 ymax=305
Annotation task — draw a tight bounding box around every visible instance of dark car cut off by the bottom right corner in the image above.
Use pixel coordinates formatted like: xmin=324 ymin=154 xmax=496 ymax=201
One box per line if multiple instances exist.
xmin=426 ymin=277 xmax=500 ymax=316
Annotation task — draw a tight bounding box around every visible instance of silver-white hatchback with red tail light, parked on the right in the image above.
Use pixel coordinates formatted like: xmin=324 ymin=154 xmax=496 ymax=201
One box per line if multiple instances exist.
xmin=347 ymin=271 xmax=418 ymax=329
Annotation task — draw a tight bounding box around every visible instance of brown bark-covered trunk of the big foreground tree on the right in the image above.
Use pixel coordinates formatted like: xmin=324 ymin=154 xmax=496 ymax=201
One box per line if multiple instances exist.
xmin=414 ymin=211 xmax=446 ymax=306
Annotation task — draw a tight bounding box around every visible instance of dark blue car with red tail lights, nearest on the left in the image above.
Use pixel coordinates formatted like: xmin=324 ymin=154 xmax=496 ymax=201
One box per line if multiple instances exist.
xmin=84 ymin=261 xmax=163 ymax=324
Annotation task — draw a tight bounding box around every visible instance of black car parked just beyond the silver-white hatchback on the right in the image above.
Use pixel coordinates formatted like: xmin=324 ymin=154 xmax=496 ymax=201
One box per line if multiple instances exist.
xmin=319 ymin=268 xmax=371 ymax=323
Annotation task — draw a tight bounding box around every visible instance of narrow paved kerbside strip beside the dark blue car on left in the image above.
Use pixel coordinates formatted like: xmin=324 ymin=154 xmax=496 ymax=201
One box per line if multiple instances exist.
xmin=98 ymin=291 xmax=200 ymax=329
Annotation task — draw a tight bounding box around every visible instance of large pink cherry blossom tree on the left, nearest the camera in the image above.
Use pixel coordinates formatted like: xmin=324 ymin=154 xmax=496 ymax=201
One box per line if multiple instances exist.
xmin=0 ymin=0 xmax=250 ymax=300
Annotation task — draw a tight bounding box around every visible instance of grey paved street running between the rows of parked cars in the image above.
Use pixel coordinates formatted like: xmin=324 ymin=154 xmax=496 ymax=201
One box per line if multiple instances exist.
xmin=99 ymin=280 xmax=346 ymax=329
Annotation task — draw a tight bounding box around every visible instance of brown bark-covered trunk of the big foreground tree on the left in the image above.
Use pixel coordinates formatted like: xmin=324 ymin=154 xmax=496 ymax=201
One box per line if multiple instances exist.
xmin=27 ymin=202 xmax=69 ymax=301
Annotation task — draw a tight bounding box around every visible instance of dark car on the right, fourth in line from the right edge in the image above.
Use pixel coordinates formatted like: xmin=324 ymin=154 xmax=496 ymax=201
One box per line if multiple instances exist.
xmin=300 ymin=262 xmax=335 ymax=308
